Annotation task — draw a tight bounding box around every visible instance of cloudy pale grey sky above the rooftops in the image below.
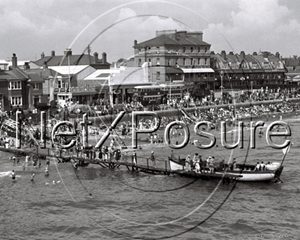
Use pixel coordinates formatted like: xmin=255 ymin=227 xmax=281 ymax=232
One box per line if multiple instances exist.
xmin=0 ymin=0 xmax=300 ymax=62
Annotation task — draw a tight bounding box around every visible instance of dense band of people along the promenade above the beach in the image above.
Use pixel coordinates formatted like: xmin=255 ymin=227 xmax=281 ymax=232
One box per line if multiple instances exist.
xmin=51 ymin=87 xmax=300 ymax=116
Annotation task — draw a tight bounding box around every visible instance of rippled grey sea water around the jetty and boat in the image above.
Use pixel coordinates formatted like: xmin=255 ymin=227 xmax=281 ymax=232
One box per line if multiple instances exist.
xmin=0 ymin=116 xmax=300 ymax=239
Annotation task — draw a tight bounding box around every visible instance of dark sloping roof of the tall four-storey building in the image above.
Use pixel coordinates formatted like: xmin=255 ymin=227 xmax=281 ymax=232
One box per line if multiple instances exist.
xmin=133 ymin=33 xmax=210 ymax=48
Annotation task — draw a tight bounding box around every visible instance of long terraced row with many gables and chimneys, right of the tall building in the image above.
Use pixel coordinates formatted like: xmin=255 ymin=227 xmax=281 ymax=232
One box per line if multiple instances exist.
xmin=211 ymin=51 xmax=296 ymax=100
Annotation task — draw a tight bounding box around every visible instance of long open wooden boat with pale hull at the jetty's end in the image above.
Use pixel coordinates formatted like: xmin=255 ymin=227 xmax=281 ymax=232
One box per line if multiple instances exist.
xmin=169 ymin=158 xmax=283 ymax=182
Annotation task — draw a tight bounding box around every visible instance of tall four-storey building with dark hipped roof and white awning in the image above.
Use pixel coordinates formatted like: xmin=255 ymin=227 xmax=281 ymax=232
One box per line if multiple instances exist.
xmin=133 ymin=30 xmax=214 ymax=96
